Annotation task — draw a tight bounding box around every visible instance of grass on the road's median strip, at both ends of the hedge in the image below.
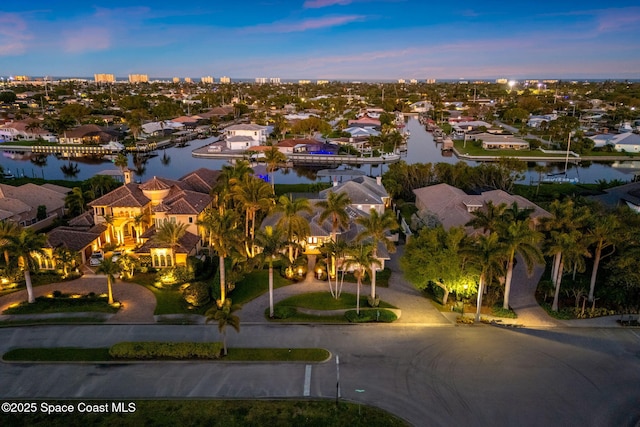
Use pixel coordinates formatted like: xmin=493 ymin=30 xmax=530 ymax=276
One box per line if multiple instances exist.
xmin=2 ymin=347 xmax=330 ymax=362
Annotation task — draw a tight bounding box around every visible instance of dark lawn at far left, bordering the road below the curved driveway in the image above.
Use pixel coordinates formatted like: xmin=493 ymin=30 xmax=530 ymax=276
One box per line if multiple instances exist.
xmin=2 ymin=294 xmax=119 ymax=314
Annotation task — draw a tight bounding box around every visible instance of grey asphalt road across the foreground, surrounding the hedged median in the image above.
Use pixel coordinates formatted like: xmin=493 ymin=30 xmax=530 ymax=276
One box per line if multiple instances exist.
xmin=0 ymin=324 xmax=640 ymax=426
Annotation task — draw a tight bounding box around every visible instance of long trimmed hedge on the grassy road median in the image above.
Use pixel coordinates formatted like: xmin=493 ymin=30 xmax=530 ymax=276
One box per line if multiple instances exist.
xmin=109 ymin=341 xmax=222 ymax=360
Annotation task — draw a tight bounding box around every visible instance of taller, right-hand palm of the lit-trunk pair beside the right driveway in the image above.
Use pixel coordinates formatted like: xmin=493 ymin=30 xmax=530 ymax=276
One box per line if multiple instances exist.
xmin=498 ymin=218 xmax=544 ymax=310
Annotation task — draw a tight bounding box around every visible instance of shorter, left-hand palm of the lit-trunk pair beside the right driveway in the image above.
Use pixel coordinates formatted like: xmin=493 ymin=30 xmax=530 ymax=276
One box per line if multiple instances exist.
xmin=460 ymin=233 xmax=506 ymax=322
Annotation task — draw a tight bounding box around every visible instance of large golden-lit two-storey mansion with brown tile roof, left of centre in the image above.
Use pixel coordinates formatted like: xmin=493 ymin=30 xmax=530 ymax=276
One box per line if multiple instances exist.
xmin=82 ymin=168 xmax=220 ymax=267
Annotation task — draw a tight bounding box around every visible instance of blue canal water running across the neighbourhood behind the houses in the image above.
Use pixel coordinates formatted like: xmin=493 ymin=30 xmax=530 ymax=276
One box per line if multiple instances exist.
xmin=0 ymin=117 xmax=640 ymax=184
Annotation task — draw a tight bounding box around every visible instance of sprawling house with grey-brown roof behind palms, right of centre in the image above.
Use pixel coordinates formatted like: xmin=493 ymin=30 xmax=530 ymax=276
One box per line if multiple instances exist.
xmin=413 ymin=184 xmax=549 ymax=234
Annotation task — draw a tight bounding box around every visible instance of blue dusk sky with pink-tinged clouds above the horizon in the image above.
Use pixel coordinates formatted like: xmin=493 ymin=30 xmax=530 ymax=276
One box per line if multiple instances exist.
xmin=0 ymin=0 xmax=640 ymax=81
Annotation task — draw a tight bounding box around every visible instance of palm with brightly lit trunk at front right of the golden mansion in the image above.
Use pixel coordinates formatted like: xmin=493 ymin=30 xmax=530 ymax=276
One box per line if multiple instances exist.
xmin=198 ymin=209 xmax=242 ymax=304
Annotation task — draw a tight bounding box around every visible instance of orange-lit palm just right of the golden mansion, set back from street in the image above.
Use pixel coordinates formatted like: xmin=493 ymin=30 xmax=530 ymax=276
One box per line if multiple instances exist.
xmin=231 ymin=175 xmax=274 ymax=258
